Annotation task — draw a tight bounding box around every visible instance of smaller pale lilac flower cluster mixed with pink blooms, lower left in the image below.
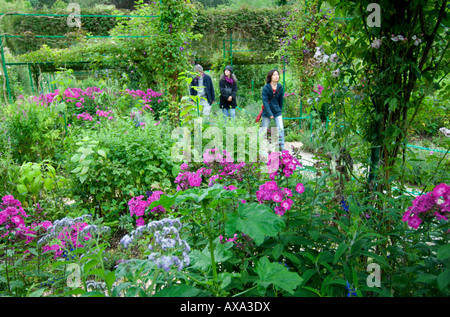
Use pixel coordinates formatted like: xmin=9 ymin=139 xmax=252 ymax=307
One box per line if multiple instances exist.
xmin=38 ymin=215 xmax=92 ymax=259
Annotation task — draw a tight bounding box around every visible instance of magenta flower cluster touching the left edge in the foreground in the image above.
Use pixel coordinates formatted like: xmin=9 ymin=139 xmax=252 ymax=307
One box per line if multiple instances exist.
xmin=0 ymin=195 xmax=51 ymax=243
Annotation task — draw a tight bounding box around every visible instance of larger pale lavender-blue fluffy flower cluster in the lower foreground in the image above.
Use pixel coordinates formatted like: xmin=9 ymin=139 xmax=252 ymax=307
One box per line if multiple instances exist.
xmin=120 ymin=218 xmax=190 ymax=272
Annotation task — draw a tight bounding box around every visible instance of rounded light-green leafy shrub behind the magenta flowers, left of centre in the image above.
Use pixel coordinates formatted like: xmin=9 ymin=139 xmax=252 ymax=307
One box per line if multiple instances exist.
xmin=66 ymin=116 xmax=178 ymax=220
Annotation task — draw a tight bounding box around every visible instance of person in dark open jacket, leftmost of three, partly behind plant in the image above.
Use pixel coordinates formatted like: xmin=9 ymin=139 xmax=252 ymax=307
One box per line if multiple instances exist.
xmin=190 ymin=64 xmax=216 ymax=117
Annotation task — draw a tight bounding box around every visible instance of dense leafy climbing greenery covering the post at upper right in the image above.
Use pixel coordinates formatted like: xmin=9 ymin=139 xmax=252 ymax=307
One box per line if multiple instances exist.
xmin=284 ymin=0 xmax=450 ymax=189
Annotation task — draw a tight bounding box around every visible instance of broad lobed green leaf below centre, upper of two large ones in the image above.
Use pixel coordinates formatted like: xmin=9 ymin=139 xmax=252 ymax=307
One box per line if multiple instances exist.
xmin=225 ymin=203 xmax=285 ymax=246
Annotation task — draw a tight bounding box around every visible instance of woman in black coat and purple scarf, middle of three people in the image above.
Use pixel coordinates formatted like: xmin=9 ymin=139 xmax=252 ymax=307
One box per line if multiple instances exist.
xmin=219 ymin=66 xmax=237 ymax=122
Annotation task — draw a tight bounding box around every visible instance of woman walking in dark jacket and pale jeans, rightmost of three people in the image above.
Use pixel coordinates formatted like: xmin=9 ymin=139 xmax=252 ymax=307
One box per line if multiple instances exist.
xmin=260 ymin=69 xmax=284 ymax=150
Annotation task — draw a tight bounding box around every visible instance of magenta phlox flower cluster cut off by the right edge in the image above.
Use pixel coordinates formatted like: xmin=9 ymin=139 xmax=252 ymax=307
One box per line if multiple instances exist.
xmin=402 ymin=183 xmax=450 ymax=229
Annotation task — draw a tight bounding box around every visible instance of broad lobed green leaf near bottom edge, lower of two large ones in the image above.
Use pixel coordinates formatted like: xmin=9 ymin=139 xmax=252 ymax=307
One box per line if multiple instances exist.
xmin=256 ymin=257 xmax=302 ymax=294
